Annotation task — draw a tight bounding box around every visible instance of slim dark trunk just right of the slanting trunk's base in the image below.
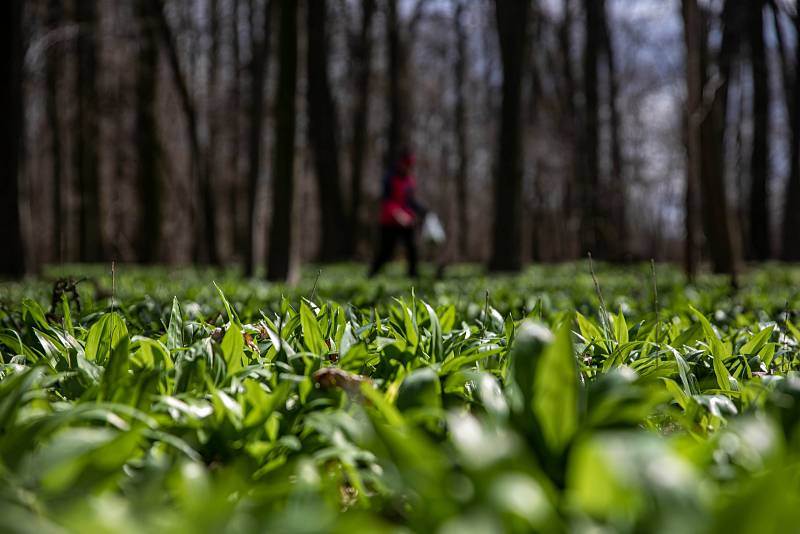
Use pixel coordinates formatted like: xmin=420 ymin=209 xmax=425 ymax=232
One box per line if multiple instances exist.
xmin=244 ymin=0 xmax=272 ymax=276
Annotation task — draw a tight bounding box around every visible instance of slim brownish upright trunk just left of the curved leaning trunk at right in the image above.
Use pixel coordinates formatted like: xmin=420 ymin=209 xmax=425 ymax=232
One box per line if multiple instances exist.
xmin=682 ymin=0 xmax=705 ymax=280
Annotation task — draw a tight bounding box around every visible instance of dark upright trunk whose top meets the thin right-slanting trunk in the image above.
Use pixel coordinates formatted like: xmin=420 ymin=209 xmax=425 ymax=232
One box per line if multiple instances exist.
xmin=135 ymin=2 xmax=162 ymax=263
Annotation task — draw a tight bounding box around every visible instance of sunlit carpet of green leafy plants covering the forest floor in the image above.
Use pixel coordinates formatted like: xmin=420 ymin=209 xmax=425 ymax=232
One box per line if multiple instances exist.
xmin=0 ymin=262 xmax=800 ymax=532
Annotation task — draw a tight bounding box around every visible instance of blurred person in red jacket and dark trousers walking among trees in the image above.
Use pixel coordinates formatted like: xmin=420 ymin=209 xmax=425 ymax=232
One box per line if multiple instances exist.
xmin=369 ymin=150 xmax=425 ymax=278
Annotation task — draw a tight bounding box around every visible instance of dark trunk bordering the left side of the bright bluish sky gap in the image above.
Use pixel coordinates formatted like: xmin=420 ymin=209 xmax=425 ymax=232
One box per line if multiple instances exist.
xmin=578 ymin=0 xmax=608 ymax=259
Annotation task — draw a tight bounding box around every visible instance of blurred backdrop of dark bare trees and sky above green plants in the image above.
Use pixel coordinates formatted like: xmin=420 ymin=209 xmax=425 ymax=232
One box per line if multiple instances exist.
xmin=0 ymin=0 xmax=800 ymax=279
